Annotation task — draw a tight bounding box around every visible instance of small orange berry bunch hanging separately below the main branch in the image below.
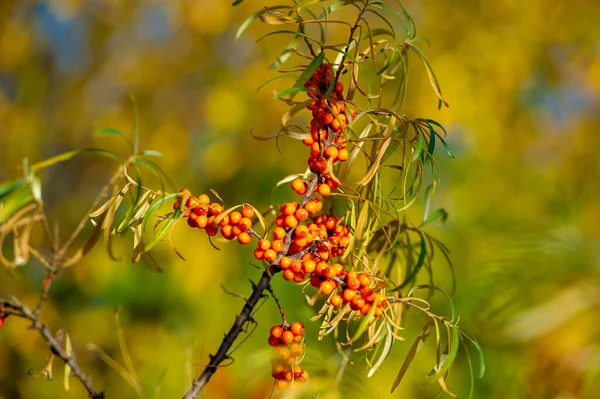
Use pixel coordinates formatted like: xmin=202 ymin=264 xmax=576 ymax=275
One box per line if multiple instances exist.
xmin=269 ymin=321 xmax=308 ymax=389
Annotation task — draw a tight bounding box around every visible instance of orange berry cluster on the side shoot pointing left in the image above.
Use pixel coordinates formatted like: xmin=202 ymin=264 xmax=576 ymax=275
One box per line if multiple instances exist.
xmin=173 ymin=188 xmax=254 ymax=244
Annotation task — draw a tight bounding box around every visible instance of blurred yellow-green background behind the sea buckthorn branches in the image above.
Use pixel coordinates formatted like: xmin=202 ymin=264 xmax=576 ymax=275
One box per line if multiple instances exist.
xmin=0 ymin=0 xmax=600 ymax=399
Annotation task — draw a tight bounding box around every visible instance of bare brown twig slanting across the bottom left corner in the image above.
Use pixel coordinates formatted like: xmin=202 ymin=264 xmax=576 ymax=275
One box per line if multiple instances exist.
xmin=0 ymin=295 xmax=104 ymax=399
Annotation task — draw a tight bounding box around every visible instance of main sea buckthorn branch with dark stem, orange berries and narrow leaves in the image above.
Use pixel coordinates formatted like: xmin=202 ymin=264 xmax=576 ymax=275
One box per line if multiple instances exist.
xmin=180 ymin=0 xmax=483 ymax=398
